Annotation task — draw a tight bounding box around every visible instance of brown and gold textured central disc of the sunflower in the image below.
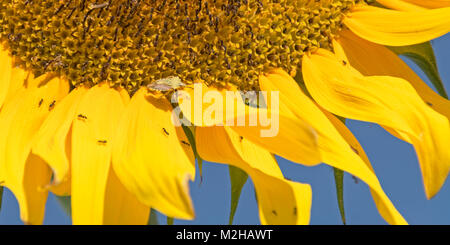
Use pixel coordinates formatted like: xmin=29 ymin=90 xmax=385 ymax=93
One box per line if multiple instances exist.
xmin=0 ymin=0 xmax=365 ymax=91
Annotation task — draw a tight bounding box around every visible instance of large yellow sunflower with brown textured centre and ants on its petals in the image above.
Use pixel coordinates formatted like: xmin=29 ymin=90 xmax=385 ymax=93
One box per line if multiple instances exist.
xmin=0 ymin=0 xmax=450 ymax=224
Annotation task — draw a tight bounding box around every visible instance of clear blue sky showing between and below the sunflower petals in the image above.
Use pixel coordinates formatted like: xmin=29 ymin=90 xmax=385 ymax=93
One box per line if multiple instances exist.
xmin=0 ymin=34 xmax=450 ymax=224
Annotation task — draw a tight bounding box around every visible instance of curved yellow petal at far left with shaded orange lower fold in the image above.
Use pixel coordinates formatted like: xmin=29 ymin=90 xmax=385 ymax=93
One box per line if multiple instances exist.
xmin=0 ymin=76 xmax=69 ymax=224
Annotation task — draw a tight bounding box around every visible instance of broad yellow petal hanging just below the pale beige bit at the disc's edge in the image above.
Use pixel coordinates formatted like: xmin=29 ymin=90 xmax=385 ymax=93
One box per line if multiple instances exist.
xmin=113 ymin=89 xmax=195 ymax=219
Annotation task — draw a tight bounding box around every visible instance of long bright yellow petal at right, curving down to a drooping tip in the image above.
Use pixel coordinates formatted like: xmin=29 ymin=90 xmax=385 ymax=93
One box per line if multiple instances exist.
xmin=302 ymin=50 xmax=450 ymax=198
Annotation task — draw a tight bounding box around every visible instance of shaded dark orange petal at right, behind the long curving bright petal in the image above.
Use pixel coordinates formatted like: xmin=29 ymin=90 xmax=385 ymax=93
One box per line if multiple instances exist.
xmin=335 ymin=31 xmax=450 ymax=128
